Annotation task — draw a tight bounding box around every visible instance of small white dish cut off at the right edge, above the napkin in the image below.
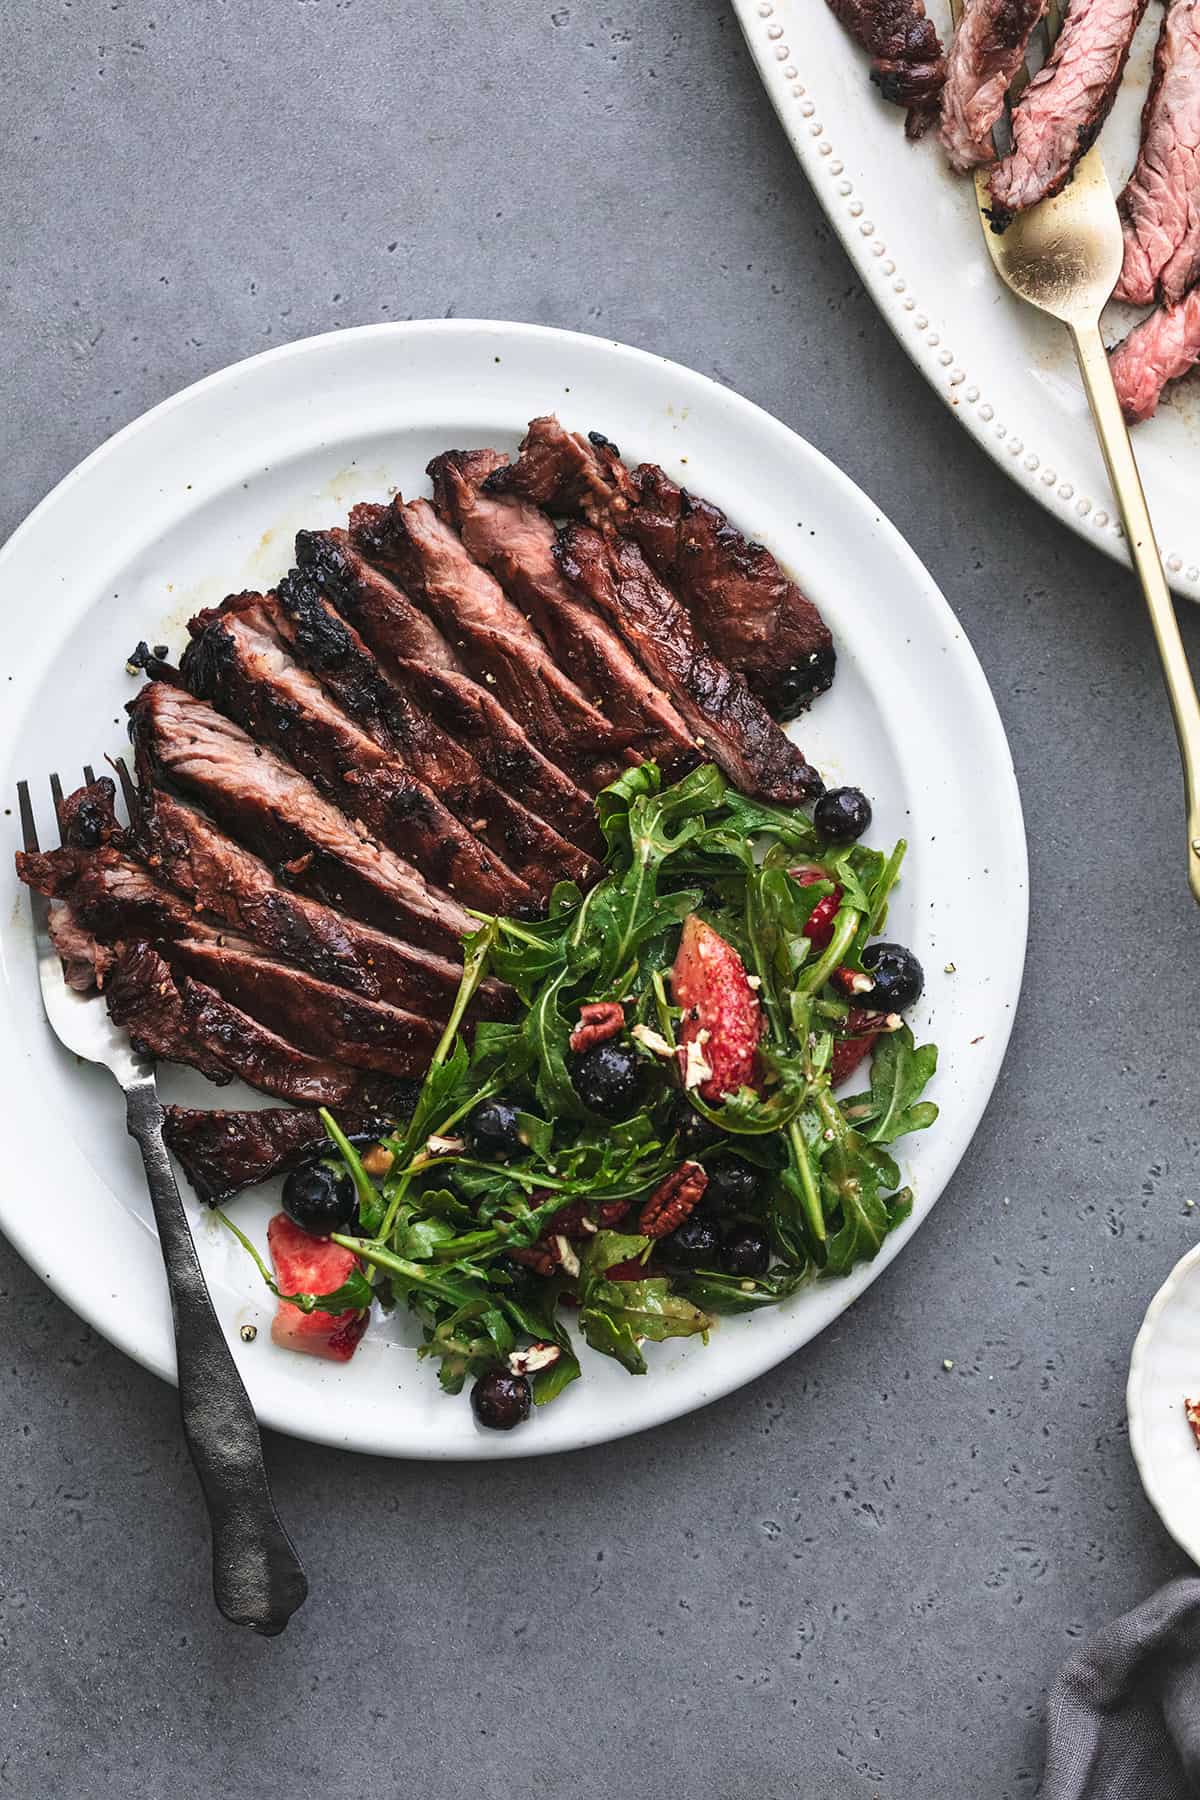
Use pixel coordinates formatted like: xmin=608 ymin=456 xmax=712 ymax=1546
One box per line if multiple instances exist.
xmin=1126 ymin=1244 xmax=1200 ymax=1562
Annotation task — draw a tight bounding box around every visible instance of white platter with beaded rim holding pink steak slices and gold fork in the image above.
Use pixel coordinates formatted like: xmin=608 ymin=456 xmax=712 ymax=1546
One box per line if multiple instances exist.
xmin=734 ymin=0 xmax=1200 ymax=599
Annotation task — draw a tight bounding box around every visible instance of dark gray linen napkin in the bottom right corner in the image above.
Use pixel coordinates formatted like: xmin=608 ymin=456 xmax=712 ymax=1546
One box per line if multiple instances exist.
xmin=1043 ymin=1575 xmax=1200 ymax=1800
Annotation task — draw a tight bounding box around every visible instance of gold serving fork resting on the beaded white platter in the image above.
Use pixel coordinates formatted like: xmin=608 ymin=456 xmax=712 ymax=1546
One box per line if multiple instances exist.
xmin=950 ymin=0 xmax=1200 ymax=902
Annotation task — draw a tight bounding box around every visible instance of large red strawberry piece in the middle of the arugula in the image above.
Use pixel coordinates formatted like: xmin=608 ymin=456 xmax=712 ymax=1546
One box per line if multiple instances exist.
xmin=671 ymin=913 xmax=763 ymax=1105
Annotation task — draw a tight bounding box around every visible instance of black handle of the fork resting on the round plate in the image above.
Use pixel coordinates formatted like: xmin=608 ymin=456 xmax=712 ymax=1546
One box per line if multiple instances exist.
xmin=126 ymin=1080 xmax=308 ymax=1638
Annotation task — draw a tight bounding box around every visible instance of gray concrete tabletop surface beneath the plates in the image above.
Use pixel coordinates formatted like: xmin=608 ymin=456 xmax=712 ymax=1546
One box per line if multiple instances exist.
xmin=0 ymin=0 xmax=1200 ymax=1800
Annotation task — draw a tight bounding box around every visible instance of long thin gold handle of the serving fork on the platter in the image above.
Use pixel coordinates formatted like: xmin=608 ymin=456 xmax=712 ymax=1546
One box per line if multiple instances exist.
xmin=1070 ymin=320 xmax=1200 ymax=902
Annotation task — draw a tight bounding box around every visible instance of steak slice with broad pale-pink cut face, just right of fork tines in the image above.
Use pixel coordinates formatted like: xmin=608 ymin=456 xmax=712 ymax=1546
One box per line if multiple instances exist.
xmin=128 ymin=682 xmax=475 ymax=954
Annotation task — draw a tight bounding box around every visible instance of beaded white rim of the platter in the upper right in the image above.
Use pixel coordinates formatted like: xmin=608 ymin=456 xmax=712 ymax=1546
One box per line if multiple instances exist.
xmin=732 ymin=0 xmax=1200 ymax=599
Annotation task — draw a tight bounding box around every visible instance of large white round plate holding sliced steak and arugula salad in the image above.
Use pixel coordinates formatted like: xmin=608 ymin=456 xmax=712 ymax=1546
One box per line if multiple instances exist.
xmin=0 ymin=320 xmax=1025 ymax=1456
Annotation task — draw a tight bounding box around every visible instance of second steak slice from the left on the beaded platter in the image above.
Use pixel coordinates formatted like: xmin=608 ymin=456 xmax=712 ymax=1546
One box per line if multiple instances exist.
xmin=941 ymin=0 xmax=1047 ymax=171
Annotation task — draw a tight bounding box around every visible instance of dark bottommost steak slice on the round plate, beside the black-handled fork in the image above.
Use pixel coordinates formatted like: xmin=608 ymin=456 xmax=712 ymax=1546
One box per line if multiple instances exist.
xmin=162 ymin=1082 xmax=402 ymax=1206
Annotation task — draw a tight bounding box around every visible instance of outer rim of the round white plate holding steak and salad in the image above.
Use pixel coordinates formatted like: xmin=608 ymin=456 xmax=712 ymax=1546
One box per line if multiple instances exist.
xmin=0 ymin=319 xmax=1029 ymax=1462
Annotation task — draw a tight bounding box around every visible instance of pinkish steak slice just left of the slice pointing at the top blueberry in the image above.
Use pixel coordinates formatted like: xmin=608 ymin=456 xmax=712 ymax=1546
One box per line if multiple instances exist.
xmin=428 ymin=450 xmax=698 ymax=778
